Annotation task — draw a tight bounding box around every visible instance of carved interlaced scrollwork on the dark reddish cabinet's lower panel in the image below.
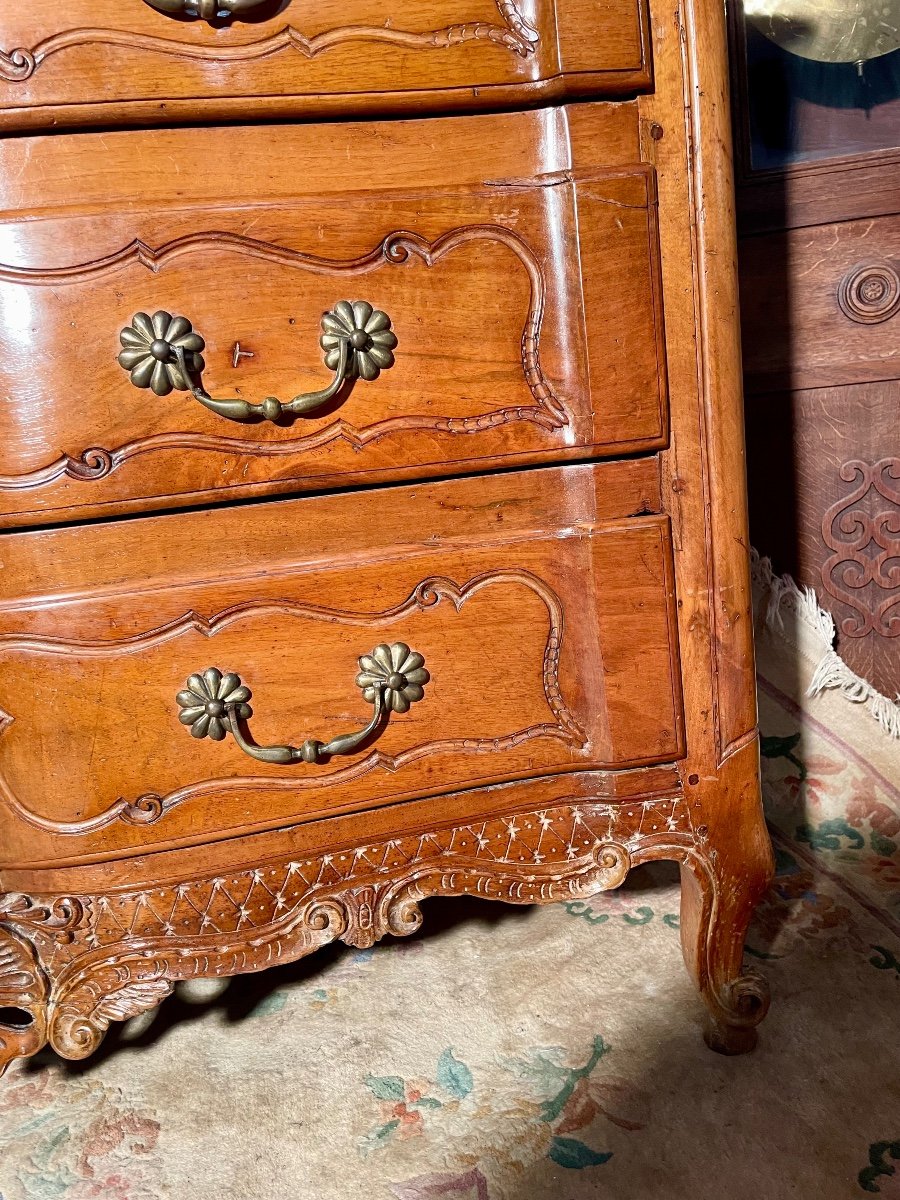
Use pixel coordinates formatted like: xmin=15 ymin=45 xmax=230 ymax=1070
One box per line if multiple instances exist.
xmin=822 ymin=458 xmax=900 ymax=637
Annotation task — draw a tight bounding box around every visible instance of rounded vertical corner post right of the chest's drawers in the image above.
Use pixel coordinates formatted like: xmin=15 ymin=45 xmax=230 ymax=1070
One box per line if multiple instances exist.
xmin=638 ymin=2 xmax=756 ymax=775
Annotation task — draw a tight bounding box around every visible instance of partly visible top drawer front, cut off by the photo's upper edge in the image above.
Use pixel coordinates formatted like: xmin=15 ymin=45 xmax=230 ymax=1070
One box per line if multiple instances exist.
xmin=0 ymin=0 xmax=649 ymax=128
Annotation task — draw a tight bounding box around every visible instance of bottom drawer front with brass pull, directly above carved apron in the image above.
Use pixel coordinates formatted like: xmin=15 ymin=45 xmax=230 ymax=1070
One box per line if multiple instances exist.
xmin=0 ymin=460 xmax=682 ymax=864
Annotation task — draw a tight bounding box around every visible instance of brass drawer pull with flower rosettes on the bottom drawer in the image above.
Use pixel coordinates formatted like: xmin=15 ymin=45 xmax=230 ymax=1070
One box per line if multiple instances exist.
xmin=175 ymin=642 xmax=430 ymax=763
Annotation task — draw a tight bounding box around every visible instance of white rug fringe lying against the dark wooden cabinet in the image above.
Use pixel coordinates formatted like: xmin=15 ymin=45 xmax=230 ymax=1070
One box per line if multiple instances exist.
xmin=750 ymin=548 xmax=900 ymax=739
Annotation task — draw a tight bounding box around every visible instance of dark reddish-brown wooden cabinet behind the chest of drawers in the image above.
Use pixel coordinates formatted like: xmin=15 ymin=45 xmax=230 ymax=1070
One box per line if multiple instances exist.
xmin=731 ymin=5 xmax=900 ymax=698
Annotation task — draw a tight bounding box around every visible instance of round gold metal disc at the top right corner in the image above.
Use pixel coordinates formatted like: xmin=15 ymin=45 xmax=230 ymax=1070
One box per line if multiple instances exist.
xmin=744 ymin=0 xmax=900 ymax=65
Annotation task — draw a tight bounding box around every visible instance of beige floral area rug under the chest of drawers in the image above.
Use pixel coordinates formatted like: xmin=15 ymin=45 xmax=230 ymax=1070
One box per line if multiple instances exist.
xmin=0 ymin=576 xmax=900 ymax=1200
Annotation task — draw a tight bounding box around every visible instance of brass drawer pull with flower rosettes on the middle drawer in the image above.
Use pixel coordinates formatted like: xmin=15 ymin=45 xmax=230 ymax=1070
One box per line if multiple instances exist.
xmin=119 ymin=300 xmax=397 ymax=421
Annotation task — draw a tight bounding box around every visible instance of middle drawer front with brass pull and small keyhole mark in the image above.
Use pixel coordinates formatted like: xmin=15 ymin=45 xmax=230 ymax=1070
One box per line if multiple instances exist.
xmin=0 ymin=106 xmax=667 ymax=523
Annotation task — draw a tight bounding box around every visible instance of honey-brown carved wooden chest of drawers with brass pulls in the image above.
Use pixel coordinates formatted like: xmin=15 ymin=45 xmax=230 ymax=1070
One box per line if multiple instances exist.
xmin=0 ymin=0 xmax=770 ymax=1066
